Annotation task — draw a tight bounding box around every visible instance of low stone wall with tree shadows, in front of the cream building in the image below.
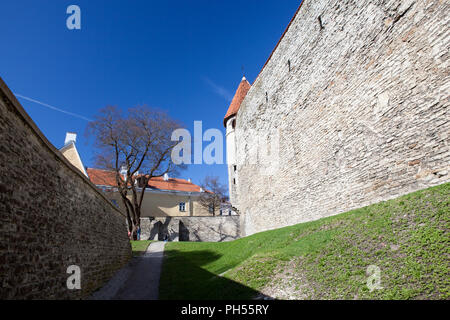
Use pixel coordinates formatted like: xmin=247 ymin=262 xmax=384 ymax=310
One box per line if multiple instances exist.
xmin=141 ymin=216 xmax=240 ymax=242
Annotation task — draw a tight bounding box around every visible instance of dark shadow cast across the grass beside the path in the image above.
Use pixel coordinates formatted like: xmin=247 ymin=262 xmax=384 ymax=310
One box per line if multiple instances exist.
xmin=159 ymin=250 xmax=271 ymax=300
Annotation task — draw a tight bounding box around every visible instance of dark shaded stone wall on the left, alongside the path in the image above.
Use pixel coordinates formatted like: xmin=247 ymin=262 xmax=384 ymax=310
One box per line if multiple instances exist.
xmin=0 ymin=79 xmax=131 ymax=299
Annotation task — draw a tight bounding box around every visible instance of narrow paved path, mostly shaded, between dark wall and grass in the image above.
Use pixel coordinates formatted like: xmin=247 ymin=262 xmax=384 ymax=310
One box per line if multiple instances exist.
xmin=91 ymin=242 xmax=165 ymax=300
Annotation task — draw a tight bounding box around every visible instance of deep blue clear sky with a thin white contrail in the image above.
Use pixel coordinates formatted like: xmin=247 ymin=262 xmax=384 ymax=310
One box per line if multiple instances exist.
xmin=0 ymin=0 xmax=300 ymax=189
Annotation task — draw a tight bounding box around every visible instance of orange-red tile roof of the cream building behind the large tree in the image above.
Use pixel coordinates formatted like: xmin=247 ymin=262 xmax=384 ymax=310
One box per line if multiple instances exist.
xmin=86 ymin=168 xmax=200 ymax=192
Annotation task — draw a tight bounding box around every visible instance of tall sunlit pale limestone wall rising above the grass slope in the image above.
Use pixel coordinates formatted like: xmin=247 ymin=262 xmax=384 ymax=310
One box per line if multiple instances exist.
xmin=236 ymin=0 xmax=450 ymax=235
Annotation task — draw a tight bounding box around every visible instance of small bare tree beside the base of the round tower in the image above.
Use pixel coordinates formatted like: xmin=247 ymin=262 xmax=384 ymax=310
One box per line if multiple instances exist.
xmin=200 ymin=176 xmax=228 ymax=216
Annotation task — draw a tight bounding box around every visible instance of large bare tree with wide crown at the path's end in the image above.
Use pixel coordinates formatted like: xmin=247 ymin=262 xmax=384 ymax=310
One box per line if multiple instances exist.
xmin=86 ymin=106 xmax=184 ymax=239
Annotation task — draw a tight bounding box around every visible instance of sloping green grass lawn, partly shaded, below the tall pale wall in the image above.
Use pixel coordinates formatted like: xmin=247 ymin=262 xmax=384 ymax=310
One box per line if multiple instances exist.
xmin=160 ymin=183 xmax=450 ymax=299
